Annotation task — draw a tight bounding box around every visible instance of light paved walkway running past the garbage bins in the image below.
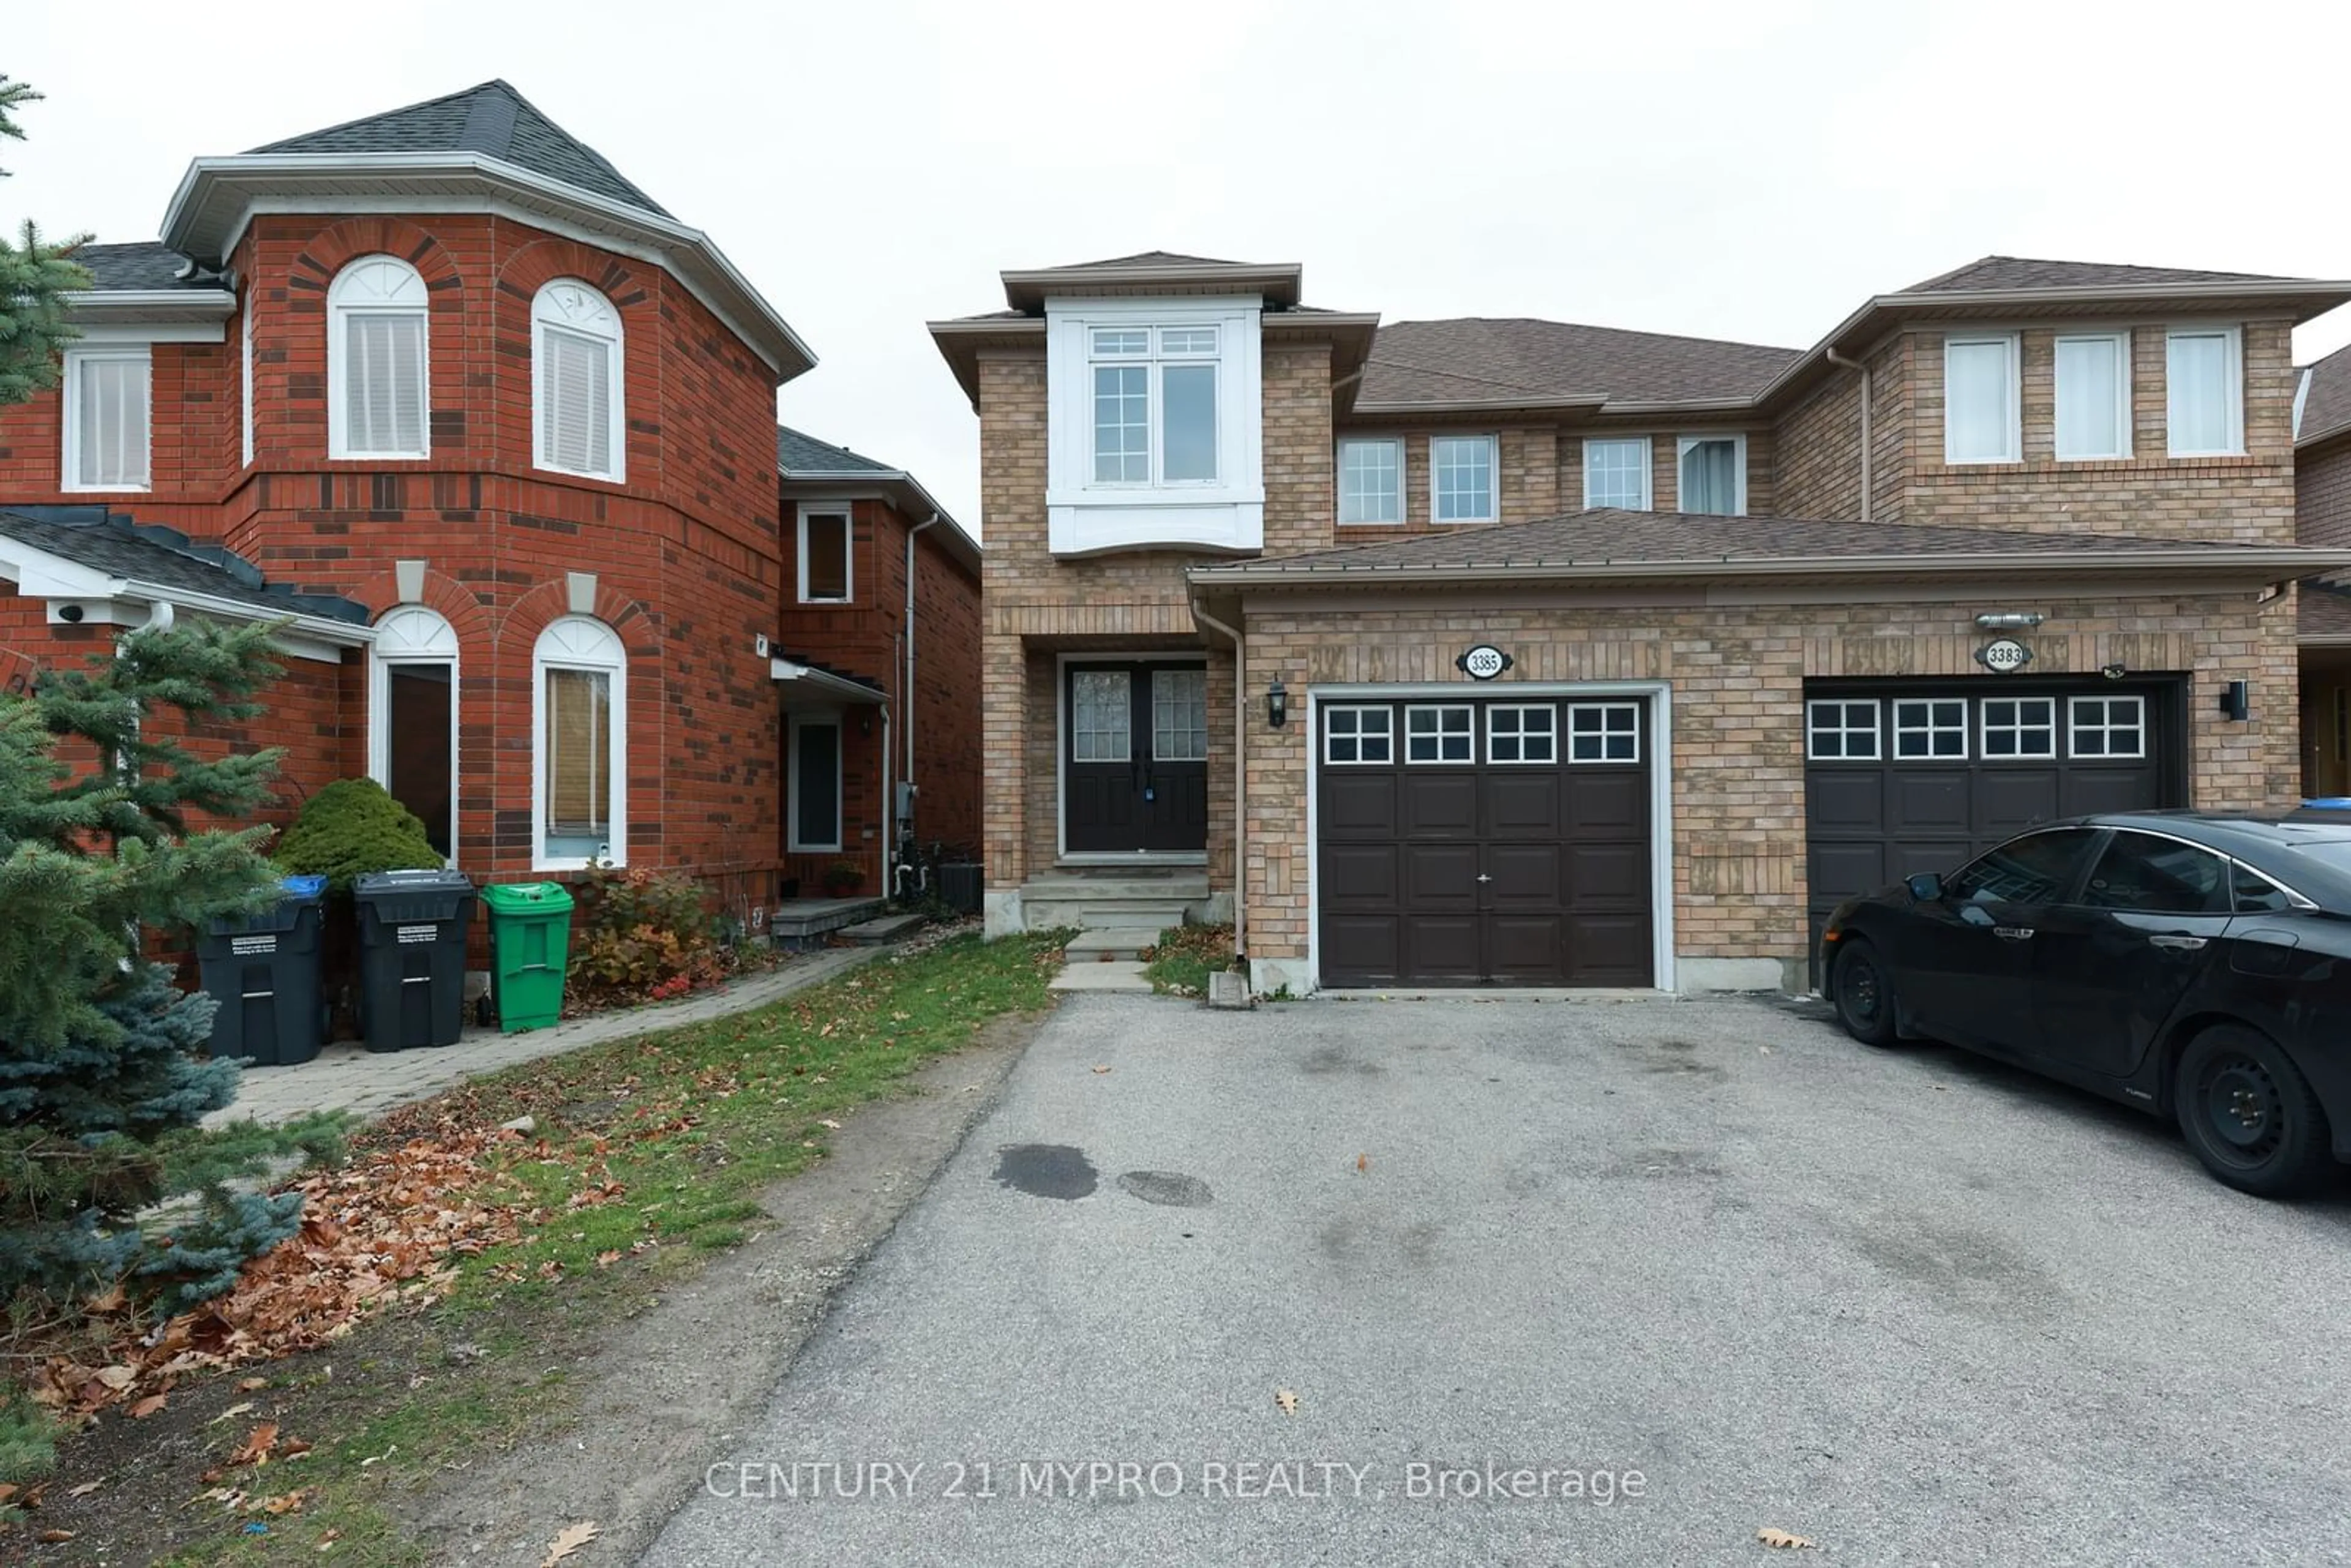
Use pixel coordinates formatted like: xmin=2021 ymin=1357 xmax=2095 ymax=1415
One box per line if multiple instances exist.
xmin=204 ymin=947 xmax=883 ymax=1126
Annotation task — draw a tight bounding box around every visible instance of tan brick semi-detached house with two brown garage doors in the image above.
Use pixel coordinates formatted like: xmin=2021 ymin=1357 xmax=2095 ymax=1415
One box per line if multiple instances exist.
xmin=931 ymin=252 xmax=2351 ymax=994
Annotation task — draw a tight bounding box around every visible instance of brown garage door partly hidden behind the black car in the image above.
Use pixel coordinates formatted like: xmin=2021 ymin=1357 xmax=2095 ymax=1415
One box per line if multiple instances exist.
xmin=1803 ymin=675 xmax=2186 ymax=980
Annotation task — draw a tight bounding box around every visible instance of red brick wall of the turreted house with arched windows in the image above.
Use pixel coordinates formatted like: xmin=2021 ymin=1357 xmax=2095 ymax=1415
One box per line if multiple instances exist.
xmin=0 ymin=214 xmax=783 ymax=898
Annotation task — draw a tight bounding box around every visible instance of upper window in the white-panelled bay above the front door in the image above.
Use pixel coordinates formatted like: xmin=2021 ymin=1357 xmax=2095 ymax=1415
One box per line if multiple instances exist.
xmin=1086 ymin=324 xmax=1223 ymax=484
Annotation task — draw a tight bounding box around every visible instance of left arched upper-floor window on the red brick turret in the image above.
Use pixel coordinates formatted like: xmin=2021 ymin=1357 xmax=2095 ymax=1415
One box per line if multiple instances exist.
xmin=327 ymin=257 xmax=430 ymax=459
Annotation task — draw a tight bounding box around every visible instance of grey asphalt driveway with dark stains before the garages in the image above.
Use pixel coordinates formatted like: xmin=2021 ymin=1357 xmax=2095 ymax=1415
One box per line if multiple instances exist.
xmin=647 ymin=997 xmax=2351 ymax=1568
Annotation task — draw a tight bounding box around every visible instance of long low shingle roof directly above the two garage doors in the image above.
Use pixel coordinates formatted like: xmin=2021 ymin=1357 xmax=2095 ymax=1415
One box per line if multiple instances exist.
xmin=1201 ymin=508 xmax=2262 ymax=579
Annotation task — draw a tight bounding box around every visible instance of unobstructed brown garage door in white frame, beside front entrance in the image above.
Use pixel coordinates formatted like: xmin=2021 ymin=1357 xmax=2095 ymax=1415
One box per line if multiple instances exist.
xmin=1314 ymin=696 xmax=1653 ymax=985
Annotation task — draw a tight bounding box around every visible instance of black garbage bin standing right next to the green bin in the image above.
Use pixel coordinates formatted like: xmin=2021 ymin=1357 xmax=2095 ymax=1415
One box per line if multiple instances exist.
xmin=350 ymin=872 xmax=473 ymax=1051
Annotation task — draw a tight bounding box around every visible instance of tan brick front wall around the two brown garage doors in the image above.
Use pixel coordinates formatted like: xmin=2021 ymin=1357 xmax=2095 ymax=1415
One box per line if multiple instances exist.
xmin=1246 ymin=593 xmax=2300 ymax=982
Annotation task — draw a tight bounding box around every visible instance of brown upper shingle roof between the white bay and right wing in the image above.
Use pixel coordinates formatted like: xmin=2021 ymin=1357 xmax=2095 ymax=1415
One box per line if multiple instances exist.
xmin=1359 ymin=317 xmax=1799 ymax=404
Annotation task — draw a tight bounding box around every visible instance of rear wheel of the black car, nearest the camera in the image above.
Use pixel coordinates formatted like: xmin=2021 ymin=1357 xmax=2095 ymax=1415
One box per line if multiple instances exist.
xmin=2172 ymin=1022 xmax=2334 ymax=1196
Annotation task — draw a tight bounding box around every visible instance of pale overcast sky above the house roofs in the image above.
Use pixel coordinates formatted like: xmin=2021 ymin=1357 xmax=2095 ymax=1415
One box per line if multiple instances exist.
xmin=0 ymin=0 xmax=2351 ymax=529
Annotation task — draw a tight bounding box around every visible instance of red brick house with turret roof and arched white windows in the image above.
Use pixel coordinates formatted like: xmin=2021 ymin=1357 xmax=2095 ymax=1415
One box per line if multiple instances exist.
xmin=0 ymin=82 xmax=978 ymax=912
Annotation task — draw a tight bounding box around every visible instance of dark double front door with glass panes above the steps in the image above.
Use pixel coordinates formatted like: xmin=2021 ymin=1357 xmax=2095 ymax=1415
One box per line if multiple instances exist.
xmin=1060 ymin=661 xmax=1209 ymax=856
